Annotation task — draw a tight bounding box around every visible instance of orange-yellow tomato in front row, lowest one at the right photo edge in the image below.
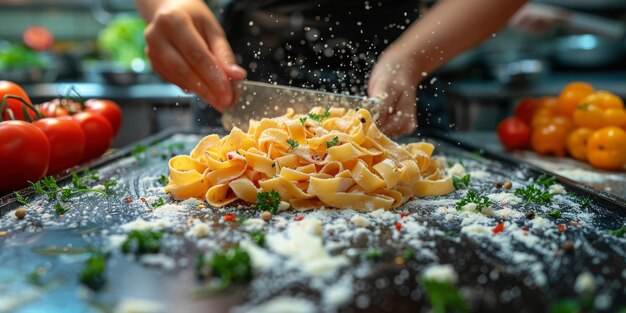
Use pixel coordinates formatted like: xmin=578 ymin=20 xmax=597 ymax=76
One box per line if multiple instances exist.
xmin=587 ymin=126 xmax=626 ymax=170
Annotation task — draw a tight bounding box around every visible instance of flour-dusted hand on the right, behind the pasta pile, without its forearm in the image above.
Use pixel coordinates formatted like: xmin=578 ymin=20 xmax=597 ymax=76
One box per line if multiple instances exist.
xmin=368 ymin=49 xmax=419 ymax=136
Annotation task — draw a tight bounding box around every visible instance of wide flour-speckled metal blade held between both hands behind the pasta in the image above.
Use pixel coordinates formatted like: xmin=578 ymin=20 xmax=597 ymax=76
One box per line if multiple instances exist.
xmin=222 ymin=80 xmax=380 ymax=130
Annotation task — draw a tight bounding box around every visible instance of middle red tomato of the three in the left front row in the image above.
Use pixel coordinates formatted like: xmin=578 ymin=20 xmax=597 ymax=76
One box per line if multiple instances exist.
xmin=33 ymin=117 xmax=85 ymax=175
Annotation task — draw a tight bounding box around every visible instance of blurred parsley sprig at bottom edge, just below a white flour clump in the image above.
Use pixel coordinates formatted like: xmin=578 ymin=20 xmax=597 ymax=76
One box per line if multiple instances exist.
xmin=420 ymin=277 xmax=469 ymax=313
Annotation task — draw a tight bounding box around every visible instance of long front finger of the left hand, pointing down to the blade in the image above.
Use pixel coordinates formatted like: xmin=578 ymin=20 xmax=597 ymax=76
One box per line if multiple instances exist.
xmin=157 ymin=14 xmax=233 ymax=107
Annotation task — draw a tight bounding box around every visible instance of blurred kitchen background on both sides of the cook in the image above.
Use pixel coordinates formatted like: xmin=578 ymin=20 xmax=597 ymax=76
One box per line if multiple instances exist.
xmin=0 ymin=0 xmax=626 ymax=147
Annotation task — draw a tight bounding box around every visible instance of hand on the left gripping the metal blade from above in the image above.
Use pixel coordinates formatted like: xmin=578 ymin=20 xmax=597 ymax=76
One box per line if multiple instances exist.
xmin=145 ymin=0 xmax=246 ymax=111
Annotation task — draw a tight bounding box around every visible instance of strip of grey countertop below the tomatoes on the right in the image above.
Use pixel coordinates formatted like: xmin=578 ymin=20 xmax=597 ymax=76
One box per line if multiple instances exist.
xmin=450 ymin=132 xmax=626 ymax=199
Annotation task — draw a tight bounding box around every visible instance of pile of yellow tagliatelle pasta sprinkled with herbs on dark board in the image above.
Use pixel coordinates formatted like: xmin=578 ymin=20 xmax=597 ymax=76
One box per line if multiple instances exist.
xmin=165 ymin=108 xmax=454 ymax=210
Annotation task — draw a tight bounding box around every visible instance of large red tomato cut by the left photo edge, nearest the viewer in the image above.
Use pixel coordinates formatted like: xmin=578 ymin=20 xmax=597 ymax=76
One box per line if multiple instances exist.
xmin=0 ymin=121 xmax=50 ymax=193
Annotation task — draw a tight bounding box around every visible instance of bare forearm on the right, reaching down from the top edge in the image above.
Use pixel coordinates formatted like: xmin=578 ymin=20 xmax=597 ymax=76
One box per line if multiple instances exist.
xmin=385 ymin=0 xmax=526 ymax=82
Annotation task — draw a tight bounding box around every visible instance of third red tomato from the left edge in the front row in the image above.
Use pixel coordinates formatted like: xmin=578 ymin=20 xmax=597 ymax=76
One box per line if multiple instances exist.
xmin=72 ymin=112 xmax=113 ymax=162
